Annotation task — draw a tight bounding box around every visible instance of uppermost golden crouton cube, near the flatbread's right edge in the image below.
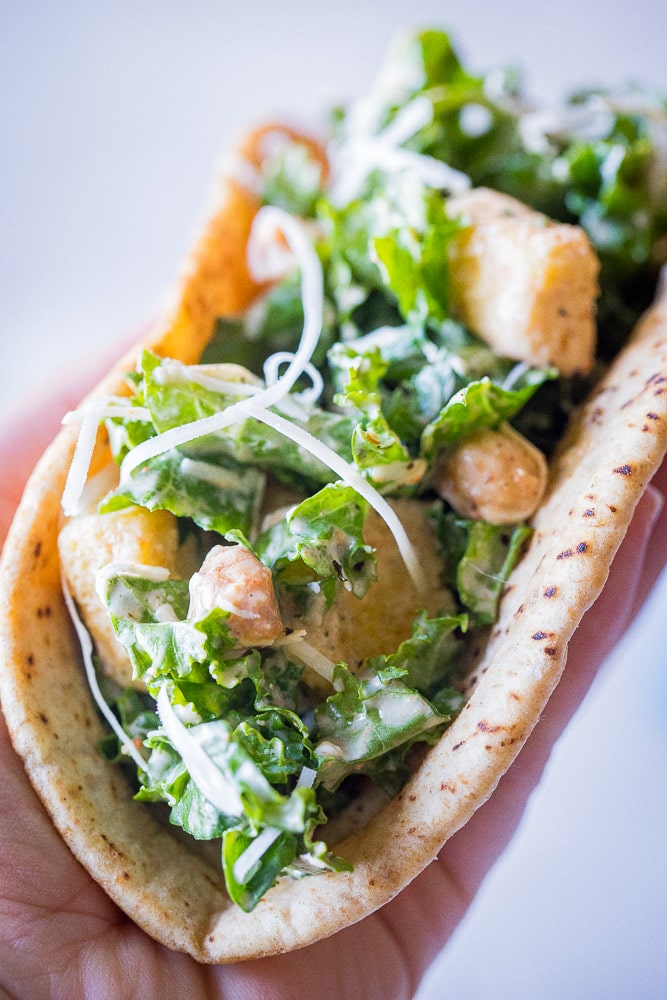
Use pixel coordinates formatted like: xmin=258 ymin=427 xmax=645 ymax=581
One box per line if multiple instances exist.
xmin=448 ymin=188 xmax=599 ymax=375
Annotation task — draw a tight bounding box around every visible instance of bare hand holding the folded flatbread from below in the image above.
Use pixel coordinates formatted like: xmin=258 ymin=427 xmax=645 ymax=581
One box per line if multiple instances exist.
xmin=0 ymin=356 xmax=667 ymax=1000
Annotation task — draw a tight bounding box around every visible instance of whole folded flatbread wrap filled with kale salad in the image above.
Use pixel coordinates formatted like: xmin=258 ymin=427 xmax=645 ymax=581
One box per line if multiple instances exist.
xmin=0 ymin=31 xmax=667 ymax=962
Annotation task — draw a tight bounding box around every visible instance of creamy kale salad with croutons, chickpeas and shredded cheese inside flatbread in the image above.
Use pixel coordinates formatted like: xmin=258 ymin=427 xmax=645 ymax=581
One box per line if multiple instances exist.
xmin=60 ymin=31 xmax=667 ymax=911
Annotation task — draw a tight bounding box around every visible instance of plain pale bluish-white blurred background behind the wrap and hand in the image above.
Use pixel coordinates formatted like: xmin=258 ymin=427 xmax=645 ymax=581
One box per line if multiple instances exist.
xmin=0 ymin=0 xmax=667 ymax=1000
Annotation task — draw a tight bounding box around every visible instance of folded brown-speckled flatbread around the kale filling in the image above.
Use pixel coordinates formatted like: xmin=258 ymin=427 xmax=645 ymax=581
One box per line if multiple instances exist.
xmin=0 ymin=148 xmax=667 ymax=963
